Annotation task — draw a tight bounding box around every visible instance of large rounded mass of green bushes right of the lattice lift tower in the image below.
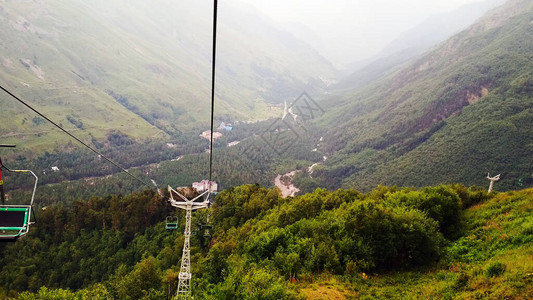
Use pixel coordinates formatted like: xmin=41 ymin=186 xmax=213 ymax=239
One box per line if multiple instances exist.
xmin=208 ymin=186 xmax=443 ymax=278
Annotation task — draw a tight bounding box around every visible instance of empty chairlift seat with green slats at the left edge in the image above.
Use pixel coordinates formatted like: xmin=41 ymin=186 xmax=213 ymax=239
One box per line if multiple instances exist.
xmin=0 ymin=155 xmax=39 ymax=242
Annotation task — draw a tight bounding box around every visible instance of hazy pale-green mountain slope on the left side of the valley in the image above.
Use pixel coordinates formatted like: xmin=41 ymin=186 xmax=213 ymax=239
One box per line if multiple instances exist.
xmin=0 ymin=0 xmax=335 ymax=151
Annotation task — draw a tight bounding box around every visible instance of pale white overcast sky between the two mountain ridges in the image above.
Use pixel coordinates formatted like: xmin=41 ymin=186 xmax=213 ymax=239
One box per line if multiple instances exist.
xmin=233 ymin=0 xmax=498 ymax=66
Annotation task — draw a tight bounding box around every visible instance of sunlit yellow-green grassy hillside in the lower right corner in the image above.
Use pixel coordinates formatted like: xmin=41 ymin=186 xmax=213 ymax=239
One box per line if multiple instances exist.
xmin=324 ymin=189 xmax=533 ymax=299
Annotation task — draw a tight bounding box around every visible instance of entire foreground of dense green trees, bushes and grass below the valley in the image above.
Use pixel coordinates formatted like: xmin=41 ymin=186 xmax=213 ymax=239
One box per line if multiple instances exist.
xmin=0 ymin=185 xmax=533 ymax=299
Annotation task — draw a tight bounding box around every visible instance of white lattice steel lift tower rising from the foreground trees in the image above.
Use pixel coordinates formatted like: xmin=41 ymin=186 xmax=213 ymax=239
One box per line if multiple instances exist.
xmin=168 ymin=186 xmax=211 ymax=299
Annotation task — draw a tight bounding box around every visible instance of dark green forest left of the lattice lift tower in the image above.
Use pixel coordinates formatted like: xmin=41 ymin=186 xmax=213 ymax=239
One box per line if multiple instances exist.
xmin=0 ymin=191 xmax=169 ymax=291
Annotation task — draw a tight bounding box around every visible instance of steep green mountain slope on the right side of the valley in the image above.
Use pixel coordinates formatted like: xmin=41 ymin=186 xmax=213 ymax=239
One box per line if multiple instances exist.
xmin=304 ymin=0 xmax=533 ymax=190
